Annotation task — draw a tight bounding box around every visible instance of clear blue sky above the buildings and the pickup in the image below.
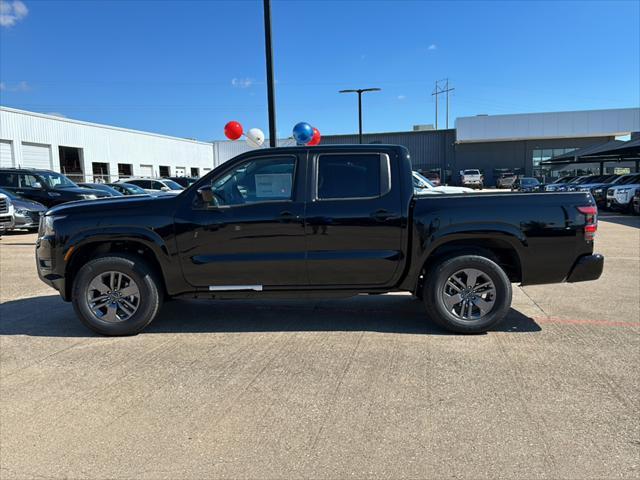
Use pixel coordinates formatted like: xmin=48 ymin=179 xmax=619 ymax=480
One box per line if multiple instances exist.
xmin=0 ymin=0 xmax=640 ymax=140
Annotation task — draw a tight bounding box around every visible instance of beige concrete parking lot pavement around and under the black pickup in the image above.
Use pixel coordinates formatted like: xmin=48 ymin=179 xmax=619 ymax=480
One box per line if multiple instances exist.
xmin=0 ymin=214 xmax=640 ymax=479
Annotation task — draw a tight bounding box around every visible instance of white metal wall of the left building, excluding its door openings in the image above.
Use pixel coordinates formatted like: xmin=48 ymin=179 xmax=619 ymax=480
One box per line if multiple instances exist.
xmin=0 ymin=107 xmax=216 ymax=178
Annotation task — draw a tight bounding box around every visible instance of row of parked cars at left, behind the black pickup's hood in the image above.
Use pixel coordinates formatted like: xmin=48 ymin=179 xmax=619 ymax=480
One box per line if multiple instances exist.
xmin=0 ymin=168 xmax=197 ymax=233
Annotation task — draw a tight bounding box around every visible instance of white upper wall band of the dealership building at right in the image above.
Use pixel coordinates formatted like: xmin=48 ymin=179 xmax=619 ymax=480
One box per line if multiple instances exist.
xmin=456 ymin=108 xmax=640 ymax=143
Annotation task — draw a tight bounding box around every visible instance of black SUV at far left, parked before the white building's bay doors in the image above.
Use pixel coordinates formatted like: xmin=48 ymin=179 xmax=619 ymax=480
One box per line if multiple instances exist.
xmin=0 ymin=168 xmax=108 ymax=208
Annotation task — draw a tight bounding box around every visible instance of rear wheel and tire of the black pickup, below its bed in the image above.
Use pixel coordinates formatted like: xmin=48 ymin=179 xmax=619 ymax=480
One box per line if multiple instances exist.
xmin=423 ymin=254 xmax=512 ymax=333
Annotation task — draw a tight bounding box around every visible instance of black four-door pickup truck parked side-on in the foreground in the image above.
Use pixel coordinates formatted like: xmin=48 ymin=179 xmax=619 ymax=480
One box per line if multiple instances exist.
xmin=36 ymin=145 xmax=604 ymax=335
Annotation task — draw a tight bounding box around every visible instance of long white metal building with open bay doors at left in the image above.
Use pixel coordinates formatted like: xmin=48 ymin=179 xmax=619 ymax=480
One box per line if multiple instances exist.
xmin=0 ymin=107 xmax=216 ymax=181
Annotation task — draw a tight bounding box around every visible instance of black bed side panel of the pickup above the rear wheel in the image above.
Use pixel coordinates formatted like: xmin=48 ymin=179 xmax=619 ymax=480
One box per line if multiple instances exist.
xmin=401 ymin=193 xmax=594 ymax=290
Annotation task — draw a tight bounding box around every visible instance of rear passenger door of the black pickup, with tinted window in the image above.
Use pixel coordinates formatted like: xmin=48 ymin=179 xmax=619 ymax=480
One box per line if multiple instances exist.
xmin=305 ymin=150 xmax=402 ymax=287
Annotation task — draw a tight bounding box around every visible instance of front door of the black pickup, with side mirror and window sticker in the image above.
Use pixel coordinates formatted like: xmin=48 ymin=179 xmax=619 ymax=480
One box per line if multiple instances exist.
xmin=176 ymin=154 xmax=307 ymax=291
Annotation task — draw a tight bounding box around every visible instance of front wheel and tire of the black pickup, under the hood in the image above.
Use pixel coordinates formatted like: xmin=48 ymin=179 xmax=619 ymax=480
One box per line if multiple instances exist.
xmin=72 ymin=254 xmax=163 ymax=336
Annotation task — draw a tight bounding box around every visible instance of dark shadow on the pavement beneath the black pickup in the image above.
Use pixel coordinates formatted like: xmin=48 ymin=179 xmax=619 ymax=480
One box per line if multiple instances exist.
xmin=0 ymin=295 xmax=541 ymax=337
